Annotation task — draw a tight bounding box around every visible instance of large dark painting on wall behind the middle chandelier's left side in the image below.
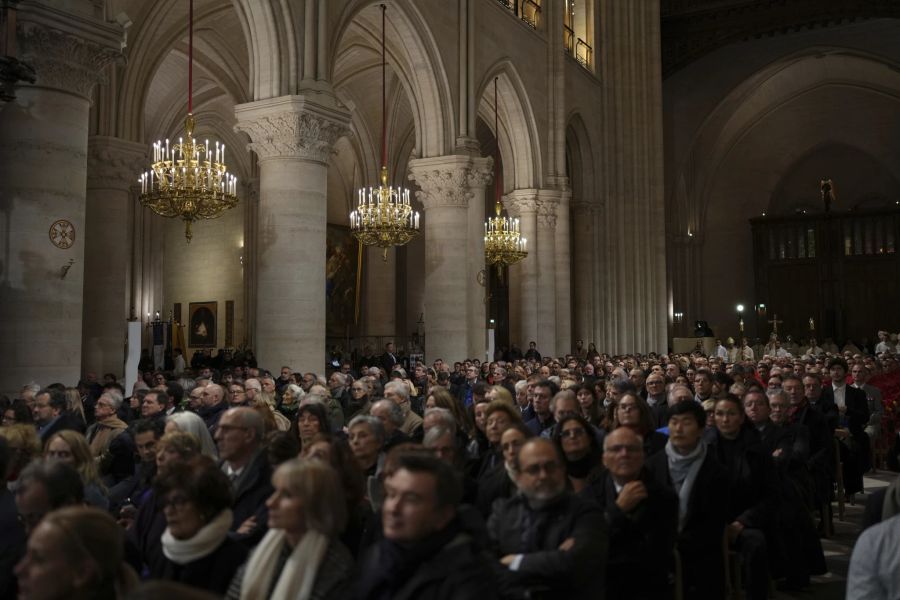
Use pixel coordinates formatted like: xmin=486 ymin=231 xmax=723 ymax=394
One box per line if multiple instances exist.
xmin=325 ymin=225 xmax=362 ymax=337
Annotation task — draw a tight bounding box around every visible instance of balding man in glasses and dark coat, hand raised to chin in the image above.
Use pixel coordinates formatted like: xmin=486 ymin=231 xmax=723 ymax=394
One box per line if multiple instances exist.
xmin=581 ymin=427 xmax=678 ymax=600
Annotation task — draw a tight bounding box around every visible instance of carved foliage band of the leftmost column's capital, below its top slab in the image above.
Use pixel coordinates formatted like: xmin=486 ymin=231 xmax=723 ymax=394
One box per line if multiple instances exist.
xmin=18 ymin=23 xmax=122 ymax=100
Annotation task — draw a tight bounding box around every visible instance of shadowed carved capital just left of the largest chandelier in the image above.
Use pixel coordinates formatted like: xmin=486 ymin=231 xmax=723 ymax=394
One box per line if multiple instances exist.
xmin=87 ymin=136 xmax=149 ymax=190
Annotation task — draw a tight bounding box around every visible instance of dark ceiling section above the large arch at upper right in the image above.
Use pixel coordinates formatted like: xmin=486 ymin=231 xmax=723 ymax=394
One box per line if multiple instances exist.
xmin=660 ymin=0 xmax=900 ymax=77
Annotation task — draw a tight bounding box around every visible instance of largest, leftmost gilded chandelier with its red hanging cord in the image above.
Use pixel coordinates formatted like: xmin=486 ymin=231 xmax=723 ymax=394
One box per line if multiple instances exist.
xmin=138 ymin=0 xmax=238 ymax=243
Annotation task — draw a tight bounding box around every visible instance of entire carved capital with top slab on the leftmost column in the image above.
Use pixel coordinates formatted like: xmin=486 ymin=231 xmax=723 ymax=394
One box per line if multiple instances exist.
xmin=16 ymin=2 xmax=124 ymax=100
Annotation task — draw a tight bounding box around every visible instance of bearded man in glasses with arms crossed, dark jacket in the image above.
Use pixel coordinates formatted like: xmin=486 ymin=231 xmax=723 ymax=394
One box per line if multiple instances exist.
xmin=488 ymin=439 xmax=607 ymax=599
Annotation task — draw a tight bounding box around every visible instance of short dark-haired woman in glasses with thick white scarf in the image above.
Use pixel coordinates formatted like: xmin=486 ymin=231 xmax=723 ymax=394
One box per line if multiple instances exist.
xmin=150 ymin=456 xmax=247 ymax=594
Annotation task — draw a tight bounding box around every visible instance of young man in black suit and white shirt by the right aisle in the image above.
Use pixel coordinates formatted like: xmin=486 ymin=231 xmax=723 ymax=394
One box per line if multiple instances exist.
xmin=822 ymin=356 xmax=871 ymax=495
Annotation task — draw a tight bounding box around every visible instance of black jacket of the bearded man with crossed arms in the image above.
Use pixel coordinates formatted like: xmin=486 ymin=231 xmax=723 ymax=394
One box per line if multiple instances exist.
xmin=488 ymin=492 xmax=608 ymax=599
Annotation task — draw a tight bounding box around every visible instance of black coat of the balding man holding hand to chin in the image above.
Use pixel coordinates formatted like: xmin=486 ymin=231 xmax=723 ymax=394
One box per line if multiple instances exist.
xmin=581 ymin=471 xmax=678 ymax=600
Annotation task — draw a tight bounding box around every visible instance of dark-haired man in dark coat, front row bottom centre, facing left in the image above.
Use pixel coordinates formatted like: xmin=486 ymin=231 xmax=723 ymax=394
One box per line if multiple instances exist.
xmin=354 ymin=453 xmax=498 ymax=600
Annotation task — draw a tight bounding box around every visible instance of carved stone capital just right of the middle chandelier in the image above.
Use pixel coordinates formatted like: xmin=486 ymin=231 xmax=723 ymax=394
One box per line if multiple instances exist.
xmin=409 ymin=155 xmax=493 ymax=211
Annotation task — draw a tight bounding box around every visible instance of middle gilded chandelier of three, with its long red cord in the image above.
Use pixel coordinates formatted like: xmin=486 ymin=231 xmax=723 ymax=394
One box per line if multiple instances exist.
xmin=350 ymin=4 xmax=419 ymax=261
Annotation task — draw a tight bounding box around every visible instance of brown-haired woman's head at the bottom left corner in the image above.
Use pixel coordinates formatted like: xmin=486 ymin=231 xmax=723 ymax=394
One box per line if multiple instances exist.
xmin=15 ymin=506 xmax=137 ymax=600
